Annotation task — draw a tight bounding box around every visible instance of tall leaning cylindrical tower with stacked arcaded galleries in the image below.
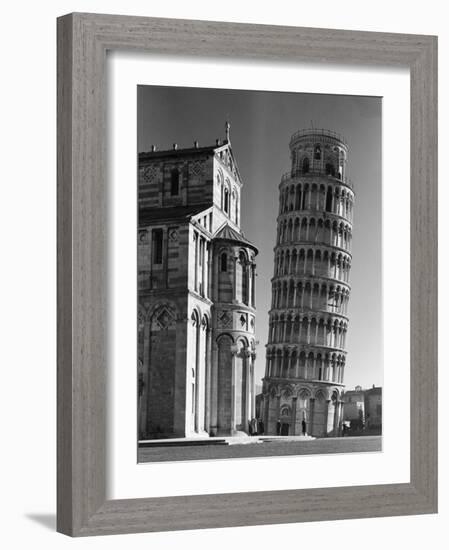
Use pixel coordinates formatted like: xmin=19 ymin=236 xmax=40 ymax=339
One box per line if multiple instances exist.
xmin=263 ymin=129 xmax=354 ymax=437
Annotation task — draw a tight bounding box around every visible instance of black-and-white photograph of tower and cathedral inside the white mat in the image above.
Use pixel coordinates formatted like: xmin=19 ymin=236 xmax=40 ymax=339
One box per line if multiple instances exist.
xmin=137 ymin=86 xmax=383 ymax=462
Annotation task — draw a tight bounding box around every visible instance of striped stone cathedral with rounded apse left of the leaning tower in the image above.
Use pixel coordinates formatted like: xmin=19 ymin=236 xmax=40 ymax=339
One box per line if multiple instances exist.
xmin=137 ymin=124 xmax=257 ymax=439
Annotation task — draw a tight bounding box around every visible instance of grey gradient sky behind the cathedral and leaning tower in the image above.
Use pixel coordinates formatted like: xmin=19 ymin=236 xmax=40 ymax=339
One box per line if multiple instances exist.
xmin=137 ymin=86 xmax=383 ymax=389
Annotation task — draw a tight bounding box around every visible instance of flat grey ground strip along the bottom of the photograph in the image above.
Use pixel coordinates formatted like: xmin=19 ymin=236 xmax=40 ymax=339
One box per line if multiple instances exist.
xmin=138 ymin=436 xmax=382 ymax=462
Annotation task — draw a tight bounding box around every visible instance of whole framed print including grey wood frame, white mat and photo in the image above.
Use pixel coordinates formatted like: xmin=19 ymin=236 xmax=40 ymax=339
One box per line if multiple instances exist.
xmin=58 ymin=14 xmax=437 ymax=536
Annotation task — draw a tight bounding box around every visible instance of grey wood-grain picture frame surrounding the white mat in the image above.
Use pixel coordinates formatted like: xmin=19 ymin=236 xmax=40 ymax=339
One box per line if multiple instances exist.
xmin=57 ymin=13 xmax=437 ymax=536
